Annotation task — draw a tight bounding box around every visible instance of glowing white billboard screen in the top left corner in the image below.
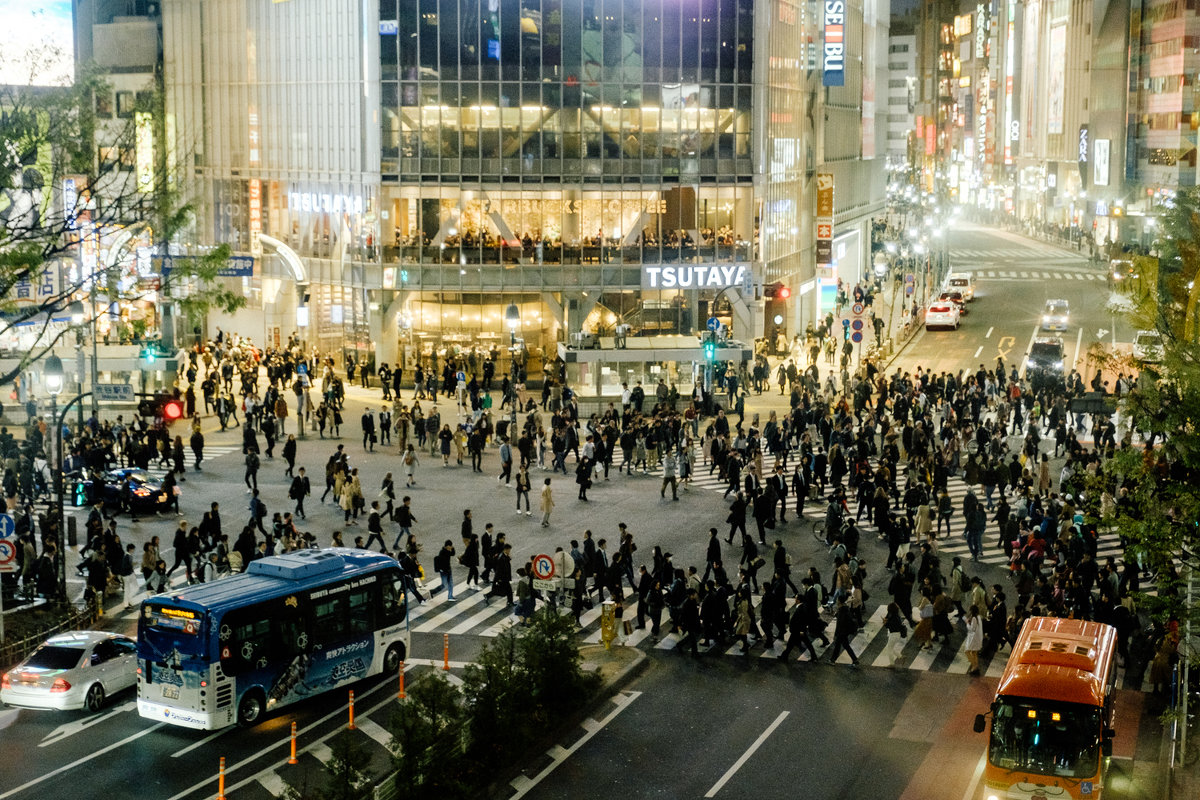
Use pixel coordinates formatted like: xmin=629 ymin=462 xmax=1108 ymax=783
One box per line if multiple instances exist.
xmin=0 ymin=0 xmax=74 ymax=86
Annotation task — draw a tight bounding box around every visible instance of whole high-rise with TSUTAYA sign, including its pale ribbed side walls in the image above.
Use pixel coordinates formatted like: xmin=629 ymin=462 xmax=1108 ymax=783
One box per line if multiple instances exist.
xmin=162 ymin=0 xmax=887 ymax=388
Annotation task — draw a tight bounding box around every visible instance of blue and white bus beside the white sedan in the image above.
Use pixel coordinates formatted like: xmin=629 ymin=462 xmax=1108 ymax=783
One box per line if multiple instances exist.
xmin=138 ymin=548 xmax=409 ymax=730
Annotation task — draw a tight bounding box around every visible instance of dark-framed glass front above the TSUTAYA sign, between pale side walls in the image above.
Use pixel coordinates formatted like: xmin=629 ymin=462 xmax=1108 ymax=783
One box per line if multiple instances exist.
xmin=379 ymin=0 xmax=760 ymax=369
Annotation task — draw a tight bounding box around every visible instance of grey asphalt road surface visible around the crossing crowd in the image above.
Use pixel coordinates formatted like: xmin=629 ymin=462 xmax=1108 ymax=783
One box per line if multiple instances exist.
xmin=0 ymin=225 xmax=1157 ymax=800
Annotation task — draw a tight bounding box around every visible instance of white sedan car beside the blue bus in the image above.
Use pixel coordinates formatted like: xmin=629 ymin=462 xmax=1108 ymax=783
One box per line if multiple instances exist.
xmin=0 ymin=631 xmax=138 ymax=711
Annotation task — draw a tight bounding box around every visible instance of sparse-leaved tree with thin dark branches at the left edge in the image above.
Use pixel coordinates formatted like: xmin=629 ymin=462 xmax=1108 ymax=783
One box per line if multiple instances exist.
xmin=0 ymin=48 xmax=245 ymax=385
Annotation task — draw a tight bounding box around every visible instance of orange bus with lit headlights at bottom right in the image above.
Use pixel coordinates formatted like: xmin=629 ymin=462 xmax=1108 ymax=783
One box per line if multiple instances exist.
xmin=974 ymin=616 xmax=1117 ymax=800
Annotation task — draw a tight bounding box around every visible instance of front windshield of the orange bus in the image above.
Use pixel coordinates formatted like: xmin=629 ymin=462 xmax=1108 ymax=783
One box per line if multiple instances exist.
xmin=988 ymin=697 xmax=1103 ymax=778
